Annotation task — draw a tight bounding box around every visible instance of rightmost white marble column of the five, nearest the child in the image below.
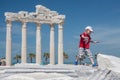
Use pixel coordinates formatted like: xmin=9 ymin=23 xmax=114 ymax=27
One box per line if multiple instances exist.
xmin=58 ymin=24 xmax=63 ymax=64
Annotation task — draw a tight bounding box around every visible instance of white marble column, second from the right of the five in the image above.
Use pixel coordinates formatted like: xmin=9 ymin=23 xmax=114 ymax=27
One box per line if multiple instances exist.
xmin=50 ymin=24 xmax=55 ymax=65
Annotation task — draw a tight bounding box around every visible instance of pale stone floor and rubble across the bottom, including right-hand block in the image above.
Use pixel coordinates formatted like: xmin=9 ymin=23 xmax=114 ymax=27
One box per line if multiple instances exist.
xmin=0 ymin=54 xmax=120 ymax=80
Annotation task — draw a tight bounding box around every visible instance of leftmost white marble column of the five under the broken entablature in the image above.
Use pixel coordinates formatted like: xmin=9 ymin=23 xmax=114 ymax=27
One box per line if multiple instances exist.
xmin=6 ymin=20 xmax=12 ymax=66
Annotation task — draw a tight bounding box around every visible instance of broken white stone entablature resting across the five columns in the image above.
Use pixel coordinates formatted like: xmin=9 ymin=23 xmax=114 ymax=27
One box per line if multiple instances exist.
xmin=5 ymin=5 xmax=65 ymax=24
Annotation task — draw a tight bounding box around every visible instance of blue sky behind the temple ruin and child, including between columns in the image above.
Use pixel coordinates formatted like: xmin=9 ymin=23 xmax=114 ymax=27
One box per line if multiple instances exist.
xmin=0 ymin=0 xmax=120 ymax=62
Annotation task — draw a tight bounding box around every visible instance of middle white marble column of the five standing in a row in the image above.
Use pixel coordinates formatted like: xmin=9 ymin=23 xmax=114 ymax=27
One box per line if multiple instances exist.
xmin=36 ymin=23 xmax=42 ymax=64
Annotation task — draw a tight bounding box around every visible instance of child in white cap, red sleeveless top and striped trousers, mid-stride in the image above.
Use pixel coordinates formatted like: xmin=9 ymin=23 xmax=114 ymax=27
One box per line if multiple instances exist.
xmin=75 ymin=26 xmax=97 ymax=66
